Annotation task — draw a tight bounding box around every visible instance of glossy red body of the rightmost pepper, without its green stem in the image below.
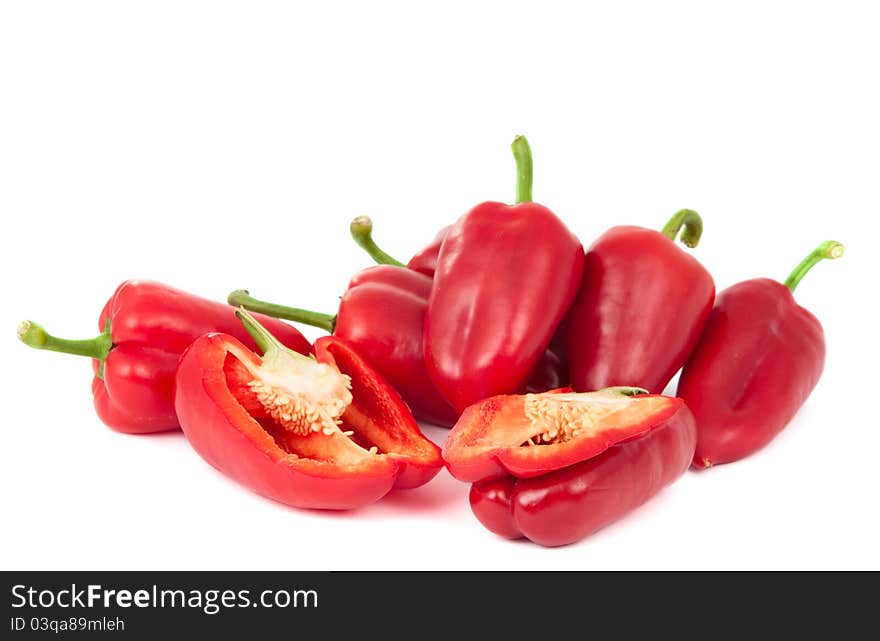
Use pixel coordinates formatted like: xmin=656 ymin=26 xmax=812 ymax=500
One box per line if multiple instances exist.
xmin=678 ymin=278 xmax=825 ymax=467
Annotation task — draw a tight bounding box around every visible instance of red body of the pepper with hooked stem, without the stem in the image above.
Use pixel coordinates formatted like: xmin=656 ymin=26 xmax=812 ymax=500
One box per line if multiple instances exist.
xmin=566 ymin=227 xmax=715 ymax=394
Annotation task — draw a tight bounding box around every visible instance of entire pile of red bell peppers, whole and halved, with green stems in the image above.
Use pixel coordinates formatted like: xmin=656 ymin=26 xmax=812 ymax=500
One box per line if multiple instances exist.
xmin=18 ymin=136 xmax=844 ymax=546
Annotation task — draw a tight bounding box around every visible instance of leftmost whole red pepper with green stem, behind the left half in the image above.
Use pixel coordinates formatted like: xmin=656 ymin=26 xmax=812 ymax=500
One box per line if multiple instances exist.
xmin=18 ymin=280 xmax=310 ymax=434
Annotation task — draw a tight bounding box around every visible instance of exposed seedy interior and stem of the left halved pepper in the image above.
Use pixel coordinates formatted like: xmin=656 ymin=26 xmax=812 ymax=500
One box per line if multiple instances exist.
xmin=216 ymin=311 xmax=442 ymax=480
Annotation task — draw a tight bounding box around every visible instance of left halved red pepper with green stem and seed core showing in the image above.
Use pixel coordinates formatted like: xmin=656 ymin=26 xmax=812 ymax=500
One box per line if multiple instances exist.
xmin=175 ymin=310 xmax=442 ymax=510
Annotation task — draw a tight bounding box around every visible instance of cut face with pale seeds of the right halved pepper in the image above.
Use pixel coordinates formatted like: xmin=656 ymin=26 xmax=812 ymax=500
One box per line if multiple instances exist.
xmin=443 ymin=387 xmax=683 ymax=482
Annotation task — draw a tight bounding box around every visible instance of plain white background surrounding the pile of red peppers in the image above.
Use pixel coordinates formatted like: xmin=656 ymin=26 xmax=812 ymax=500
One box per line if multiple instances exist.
xmin=0 ymin=1 xmax=880 ymax=569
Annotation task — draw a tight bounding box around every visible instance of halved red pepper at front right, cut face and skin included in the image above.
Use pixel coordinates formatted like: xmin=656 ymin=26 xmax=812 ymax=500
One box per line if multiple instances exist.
xmin=443 ymin=388 xmax=696 ymax=546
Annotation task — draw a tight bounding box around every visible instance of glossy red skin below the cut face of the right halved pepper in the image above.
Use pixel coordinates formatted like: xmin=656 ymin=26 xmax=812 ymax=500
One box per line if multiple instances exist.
xmin=470 ymin=405 xmax=697 ymax=547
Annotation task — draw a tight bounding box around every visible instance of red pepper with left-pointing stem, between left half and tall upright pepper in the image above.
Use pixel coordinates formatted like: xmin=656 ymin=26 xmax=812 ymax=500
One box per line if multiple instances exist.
xmin=228 ymin=265 xmax=458 ymax=426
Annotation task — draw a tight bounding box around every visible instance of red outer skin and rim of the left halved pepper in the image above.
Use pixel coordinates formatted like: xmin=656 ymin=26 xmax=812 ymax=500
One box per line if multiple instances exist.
xmin=175 ymin=334 xmax=440 ymax=510
